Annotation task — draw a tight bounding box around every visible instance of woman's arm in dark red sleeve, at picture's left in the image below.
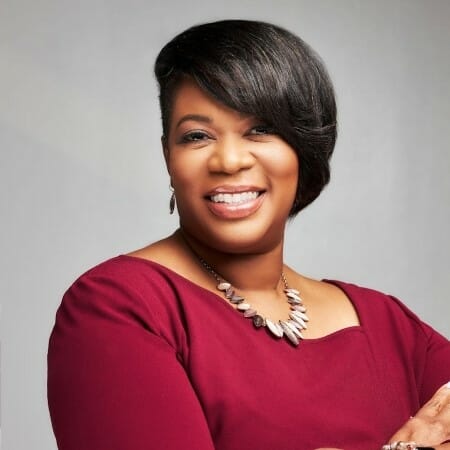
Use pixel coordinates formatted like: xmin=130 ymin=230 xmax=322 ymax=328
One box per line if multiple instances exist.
xmin=48 ymin=272 xmax=214 ymax=450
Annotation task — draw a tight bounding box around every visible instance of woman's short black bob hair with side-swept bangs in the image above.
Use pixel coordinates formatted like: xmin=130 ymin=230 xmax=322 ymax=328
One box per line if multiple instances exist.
xmin=155 ymin=20 xmax=337 ymax=217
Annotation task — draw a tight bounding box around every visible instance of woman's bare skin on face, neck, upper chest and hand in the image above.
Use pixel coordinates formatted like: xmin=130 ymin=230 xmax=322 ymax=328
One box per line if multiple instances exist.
xmin=130 ymin=79 xmax=450 ymax=450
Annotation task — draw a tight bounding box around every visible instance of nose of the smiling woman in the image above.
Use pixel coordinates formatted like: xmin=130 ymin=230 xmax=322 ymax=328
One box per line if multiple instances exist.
xmin=208 ymin=138 xmax=255 ymax=175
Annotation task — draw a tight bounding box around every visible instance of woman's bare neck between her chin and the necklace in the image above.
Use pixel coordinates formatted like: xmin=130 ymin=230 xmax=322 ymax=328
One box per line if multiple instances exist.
xmin=176 ymin=229 xmax=283 ymax=291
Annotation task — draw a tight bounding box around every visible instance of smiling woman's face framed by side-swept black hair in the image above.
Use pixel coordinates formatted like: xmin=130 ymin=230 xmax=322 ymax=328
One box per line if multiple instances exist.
xmin=164 ymin=80 xmax=298 ymax=253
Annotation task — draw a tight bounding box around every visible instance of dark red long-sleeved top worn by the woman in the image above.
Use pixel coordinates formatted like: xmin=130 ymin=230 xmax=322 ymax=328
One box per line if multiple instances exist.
xmin=48 ymin=256 xmax=450 ymax=450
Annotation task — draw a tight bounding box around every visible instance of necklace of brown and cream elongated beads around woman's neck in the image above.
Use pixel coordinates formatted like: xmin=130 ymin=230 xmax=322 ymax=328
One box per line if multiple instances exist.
xmin=195 ymin=255 xmax=309 ymax=346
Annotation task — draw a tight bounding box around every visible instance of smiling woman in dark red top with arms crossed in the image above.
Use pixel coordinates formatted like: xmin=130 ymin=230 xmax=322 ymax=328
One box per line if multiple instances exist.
xmin=48 ymin=21 xmax=450 ymax=450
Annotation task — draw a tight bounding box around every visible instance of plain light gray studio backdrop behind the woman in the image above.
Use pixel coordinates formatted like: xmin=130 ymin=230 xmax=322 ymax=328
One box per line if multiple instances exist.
xmin=0 ymin=0 xmax=450 ymax=450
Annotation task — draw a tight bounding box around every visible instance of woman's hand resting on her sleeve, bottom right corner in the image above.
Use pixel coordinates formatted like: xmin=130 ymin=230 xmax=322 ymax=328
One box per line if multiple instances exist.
xmin=389 ymin=383 xmax=450 ymax=450
